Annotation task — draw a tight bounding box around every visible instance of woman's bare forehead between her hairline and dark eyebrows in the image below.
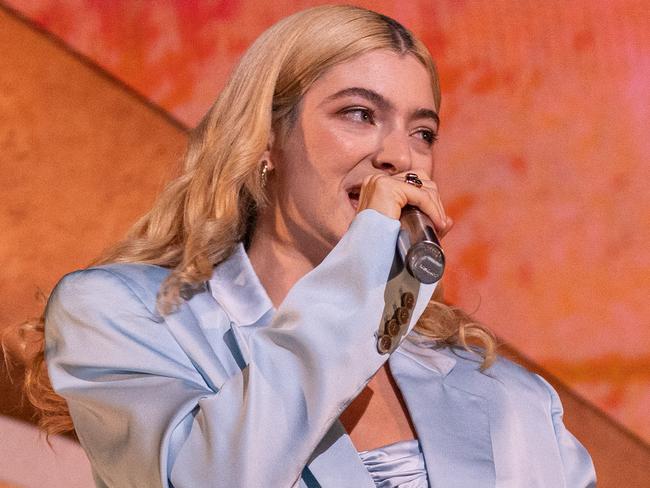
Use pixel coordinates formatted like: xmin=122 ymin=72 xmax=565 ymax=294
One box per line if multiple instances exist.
xmin=305 ymin=49 xmax=435 ymax=110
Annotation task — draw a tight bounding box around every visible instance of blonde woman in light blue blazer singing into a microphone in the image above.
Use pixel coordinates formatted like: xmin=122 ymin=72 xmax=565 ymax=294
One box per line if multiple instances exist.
xmin=22 ymin=6 xmax=594 ymax=488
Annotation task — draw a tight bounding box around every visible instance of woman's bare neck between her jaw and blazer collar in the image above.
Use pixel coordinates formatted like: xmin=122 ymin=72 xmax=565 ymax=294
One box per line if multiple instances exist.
xmin=247 ymin=207 xmax=324 ymax=308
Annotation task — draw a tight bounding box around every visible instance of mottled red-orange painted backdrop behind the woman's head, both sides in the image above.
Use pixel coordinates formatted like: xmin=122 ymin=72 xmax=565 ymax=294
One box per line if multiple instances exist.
xmin=6 ymin=0 xmax=650 ymax=441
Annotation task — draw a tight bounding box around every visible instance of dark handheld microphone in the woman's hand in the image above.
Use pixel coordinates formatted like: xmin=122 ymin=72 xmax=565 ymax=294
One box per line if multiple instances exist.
xmin=397 ymin=205 xmax=445 ymax=285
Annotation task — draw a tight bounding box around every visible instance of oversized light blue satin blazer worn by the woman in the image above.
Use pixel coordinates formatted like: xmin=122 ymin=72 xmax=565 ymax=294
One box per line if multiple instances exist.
xmin=45 ymin=210 xmax=595 ymax=488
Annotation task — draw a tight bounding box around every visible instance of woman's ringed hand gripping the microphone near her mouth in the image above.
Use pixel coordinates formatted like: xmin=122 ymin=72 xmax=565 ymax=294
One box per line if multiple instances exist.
xmin=357 ymin=172 xmax=453 ymax=238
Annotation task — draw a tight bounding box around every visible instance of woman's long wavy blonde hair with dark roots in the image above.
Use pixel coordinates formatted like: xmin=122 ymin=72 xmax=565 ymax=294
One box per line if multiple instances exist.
xmin=15 ymin=6 xmax=495 ymax=434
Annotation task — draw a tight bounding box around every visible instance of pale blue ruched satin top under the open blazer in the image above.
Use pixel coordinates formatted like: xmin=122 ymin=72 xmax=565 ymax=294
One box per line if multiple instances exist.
xmin=359 ymin=439 xmax=429 ymax=488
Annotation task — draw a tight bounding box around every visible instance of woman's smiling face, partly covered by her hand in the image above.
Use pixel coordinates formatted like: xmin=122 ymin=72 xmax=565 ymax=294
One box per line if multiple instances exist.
xmin=263 ymin=50 xmax=438 ymax=262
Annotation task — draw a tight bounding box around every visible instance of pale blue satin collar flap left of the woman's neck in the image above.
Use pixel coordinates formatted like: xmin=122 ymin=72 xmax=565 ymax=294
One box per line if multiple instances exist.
xmin=208 ymin=242 xmax=273 ymax=326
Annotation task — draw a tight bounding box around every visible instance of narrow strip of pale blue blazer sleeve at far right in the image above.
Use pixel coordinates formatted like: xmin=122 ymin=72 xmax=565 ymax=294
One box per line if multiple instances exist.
xmin=536 ymin=375 xmax=596 ymax=488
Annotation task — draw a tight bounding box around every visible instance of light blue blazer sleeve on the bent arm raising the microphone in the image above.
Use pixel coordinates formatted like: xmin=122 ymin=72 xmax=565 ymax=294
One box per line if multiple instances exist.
xmin=46 ymin=210 xmax=433 ymax=488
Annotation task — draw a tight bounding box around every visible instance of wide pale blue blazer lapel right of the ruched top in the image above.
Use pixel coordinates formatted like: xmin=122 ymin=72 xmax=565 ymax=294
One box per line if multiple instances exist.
xmin=389 ymin=339 xmax=495 ymax=488
